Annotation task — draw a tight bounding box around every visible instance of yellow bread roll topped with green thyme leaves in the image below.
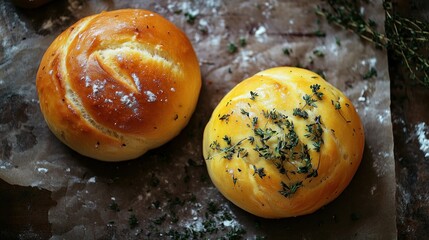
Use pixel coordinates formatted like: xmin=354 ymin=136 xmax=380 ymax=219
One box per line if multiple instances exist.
xmin=203 ymin=67 xmax=364 ymax=218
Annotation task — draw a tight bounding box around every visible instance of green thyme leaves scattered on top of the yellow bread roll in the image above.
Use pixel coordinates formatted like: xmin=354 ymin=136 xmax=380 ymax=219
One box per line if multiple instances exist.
xmin=206 ymin=87 xmax=324 ymax=197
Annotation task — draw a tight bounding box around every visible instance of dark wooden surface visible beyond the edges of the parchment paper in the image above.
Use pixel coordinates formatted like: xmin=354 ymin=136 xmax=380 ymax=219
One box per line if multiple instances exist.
xmin=0 ymin=0 xmax=429 ymax=239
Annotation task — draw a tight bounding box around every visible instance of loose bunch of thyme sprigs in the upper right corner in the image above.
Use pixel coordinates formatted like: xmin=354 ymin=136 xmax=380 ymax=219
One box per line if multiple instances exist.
xmin=316 ymin=0 xmax=429 ymax=87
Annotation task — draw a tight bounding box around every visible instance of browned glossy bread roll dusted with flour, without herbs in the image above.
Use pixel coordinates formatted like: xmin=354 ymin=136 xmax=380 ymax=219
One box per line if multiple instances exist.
xmin=37 ymin=9 xmax=201 ymax=161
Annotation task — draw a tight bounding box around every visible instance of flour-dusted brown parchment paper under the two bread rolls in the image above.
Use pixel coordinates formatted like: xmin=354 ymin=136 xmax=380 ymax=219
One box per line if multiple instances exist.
xmin=0 ymin=0 xmax=396 ymax=239
